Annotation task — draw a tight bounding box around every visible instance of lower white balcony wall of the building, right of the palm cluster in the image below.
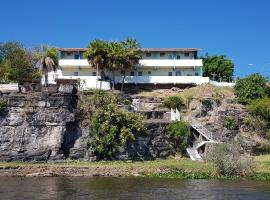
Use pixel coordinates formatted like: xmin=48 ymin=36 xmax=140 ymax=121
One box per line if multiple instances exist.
xmin=116 ymin=76 xmax=209 ymax=85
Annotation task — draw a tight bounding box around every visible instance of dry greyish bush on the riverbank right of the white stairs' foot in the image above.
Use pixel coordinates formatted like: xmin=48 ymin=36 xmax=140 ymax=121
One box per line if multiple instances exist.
xmin=210 ymin=142 xmax=254 ymax=176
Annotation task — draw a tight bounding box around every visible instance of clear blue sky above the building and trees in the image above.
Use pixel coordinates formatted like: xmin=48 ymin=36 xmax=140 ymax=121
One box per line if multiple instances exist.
xmin=0 ymin=0 xmax=270 ymax=76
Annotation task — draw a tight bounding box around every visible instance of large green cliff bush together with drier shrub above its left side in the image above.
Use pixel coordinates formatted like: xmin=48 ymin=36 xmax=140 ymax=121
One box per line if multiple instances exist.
xmin=80 ymin=90 xmax=144 ymax=160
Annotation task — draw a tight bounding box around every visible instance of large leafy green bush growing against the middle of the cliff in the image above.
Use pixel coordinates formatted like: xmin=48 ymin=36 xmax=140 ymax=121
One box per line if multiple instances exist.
xmin=88 ymin=104 xmax=144 ymax=159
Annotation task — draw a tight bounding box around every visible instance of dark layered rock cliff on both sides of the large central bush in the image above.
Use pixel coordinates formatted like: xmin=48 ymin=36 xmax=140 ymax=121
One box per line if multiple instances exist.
xmin=0 ymin=91 xmax=174 ymax=161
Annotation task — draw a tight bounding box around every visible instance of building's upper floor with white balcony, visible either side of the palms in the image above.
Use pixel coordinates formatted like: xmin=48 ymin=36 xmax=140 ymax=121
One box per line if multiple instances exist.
xmin=59 ymin=48 xmax=202 ymax=67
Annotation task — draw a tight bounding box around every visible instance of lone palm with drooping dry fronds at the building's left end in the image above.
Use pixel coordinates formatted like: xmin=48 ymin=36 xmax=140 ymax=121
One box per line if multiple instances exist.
xmin=38 ymin=46 xmax=58 ymax=87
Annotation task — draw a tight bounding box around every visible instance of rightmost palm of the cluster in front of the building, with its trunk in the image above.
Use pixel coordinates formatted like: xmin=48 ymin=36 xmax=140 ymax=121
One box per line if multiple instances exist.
xmin=121 ymin=38 xmax=142 ymax=92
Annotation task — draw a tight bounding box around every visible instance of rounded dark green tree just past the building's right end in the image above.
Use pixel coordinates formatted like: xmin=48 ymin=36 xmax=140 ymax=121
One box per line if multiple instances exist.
xmin=202 ymin=54 xmax=234 ymax=81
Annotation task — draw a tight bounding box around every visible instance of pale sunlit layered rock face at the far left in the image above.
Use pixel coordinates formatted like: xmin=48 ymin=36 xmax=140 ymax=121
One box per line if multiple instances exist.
xmin=0 ymin=93 xmax=81 ymax=161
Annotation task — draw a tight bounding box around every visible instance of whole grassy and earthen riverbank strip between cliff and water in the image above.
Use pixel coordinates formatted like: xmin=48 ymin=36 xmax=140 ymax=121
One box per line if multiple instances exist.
xmin=0 ymin=155 xmax=270 ymax=181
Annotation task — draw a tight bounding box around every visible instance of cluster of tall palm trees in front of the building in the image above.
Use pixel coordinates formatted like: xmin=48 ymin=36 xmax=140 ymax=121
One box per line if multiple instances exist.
xmin=84 ymin=38 xmax=141 ymax=91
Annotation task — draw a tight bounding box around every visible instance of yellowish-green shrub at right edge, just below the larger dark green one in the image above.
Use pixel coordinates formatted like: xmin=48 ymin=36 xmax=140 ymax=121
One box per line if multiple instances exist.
xmin=248 ymin=98 xmax=270 ymax=121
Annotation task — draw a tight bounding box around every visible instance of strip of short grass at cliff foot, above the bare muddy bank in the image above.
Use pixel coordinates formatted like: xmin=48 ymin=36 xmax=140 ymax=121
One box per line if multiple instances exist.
xmin=0 ymin=154 xmax=270 ymax=173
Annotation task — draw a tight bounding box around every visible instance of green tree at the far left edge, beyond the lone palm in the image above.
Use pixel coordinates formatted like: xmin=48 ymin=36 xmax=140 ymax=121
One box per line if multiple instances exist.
xmin=0 ymin=42 xmax=37 ymax=83
